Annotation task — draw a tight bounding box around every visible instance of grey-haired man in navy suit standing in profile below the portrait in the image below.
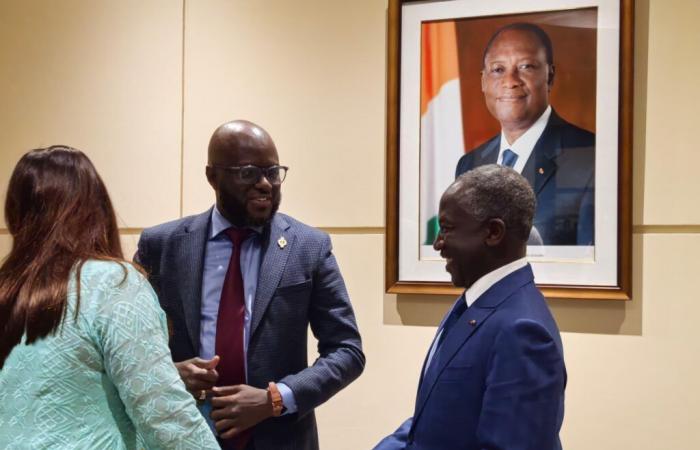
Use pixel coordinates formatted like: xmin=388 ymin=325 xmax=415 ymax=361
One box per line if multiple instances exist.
xmin=375 ymin=164 xmax=566 ymax=450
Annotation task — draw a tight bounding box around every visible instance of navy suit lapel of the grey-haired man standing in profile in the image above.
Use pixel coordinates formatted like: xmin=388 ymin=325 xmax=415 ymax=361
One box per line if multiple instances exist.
xmin=414 ymin=264 xmax=534 ymax=424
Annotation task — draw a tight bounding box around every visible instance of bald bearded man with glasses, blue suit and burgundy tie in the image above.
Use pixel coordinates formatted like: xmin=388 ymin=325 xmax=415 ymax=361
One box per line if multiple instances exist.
xmin=135 ymin=121 xmax=365 ymax=450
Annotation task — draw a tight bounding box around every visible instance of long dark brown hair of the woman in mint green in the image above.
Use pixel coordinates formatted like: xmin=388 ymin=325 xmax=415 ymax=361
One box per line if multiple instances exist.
xmin=0 ymin=145 xmax=124 ymax=369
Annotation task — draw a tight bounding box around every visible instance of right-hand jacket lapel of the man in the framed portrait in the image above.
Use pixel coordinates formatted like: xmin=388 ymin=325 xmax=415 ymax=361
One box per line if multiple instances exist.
xmin=522 ymin=110 xmax=562 ymax=195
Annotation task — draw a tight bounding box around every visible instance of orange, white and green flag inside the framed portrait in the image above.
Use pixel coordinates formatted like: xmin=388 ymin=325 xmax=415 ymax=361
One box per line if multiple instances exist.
xmin=420 ymin=21 xmax=464 ymax=245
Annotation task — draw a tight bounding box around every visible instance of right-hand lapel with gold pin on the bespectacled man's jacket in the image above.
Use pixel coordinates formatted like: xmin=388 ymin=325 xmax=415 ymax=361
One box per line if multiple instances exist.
xmin=250 ymin=214 xmax=296 ymax=337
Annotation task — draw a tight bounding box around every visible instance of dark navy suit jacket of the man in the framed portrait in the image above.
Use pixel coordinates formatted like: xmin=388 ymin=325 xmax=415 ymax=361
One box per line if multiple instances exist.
xmin=456 ymin=110 xmax=595 ymax=245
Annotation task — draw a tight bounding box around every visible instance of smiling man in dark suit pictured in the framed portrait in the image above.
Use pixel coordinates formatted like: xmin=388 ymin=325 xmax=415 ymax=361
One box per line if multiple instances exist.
xmin=456 ymin=23 xmax=595 ymax=245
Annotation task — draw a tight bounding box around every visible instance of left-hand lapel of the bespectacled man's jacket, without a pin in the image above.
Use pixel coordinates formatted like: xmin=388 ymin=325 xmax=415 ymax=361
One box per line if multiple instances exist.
xmin=172 ymin=209 xmax=211 ymax=352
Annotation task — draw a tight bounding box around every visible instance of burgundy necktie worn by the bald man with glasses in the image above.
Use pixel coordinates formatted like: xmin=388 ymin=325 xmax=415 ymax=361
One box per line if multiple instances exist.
xmin=216 ymin=228 xmax=251 ymax=450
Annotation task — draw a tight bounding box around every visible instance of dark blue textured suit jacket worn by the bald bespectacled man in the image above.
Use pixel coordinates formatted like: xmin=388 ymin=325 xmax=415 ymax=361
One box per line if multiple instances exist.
xmin=136 ymin=209 xmax=365 ymax=450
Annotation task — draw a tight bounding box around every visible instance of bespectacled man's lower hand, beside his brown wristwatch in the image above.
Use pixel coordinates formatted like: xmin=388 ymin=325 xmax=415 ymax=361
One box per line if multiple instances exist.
xmin=211 ymin=384 xmax=272 ymax=439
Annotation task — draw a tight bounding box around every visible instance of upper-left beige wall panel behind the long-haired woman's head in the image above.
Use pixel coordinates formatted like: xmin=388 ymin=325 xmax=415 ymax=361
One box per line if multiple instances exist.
xmin=0 ymin=0 xmax=182 ymax=227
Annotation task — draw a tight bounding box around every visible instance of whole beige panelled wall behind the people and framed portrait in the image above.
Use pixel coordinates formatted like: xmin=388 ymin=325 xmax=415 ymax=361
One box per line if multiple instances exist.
xmin=0 ymin=0 xmax=700 ymax=450
